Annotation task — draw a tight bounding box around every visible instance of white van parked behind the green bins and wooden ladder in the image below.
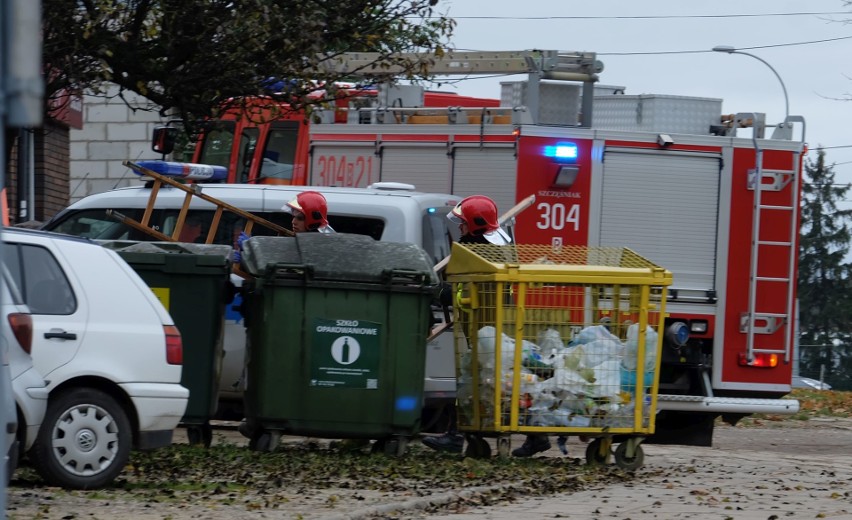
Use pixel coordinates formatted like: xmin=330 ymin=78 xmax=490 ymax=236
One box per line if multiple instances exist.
xmin=44 ymin=183 xmax=461 ymax=431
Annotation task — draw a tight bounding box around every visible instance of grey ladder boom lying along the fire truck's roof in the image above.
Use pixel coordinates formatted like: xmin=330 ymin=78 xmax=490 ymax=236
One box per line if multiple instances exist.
xmin=320 ymin=50 xmax=603 ymax=128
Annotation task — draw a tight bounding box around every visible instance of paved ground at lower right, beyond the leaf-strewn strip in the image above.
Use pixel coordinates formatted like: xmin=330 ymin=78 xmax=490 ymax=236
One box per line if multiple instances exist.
xmin=420 ymin=419 xmax=852 ymax=520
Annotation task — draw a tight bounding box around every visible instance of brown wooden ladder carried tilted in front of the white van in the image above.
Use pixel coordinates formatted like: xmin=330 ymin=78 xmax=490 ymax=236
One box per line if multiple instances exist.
xmin=112 ymin=161 xmax=293 ymax=278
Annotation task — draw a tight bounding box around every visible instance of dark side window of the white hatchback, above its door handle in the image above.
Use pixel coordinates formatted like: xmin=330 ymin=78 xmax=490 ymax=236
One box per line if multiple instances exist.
xmin=4 ymin=243 xmax=77 ymax=315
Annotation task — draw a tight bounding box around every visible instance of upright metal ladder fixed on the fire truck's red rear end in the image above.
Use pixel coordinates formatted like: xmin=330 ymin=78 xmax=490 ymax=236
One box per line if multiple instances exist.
xmin=740 ymin=114 xmax=805 ymax=364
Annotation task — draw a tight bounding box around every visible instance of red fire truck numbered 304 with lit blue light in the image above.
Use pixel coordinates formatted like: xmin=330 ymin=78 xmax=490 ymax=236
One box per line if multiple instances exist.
xmin=151 ymin=52 xmax=805 ymax=445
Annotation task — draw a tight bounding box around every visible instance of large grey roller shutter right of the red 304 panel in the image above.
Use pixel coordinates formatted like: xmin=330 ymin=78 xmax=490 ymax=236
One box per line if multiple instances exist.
xmin=600 ymin=149 xmax=721 ymax=297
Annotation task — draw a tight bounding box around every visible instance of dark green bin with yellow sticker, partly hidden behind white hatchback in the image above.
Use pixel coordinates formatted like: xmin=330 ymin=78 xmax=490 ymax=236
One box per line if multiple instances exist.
xmin=101 ymin=241 xmax=233 ymax=446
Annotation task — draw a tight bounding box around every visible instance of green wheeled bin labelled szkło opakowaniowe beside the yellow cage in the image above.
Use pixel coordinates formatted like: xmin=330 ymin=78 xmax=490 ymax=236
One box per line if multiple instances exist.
xmin=242 ymin=233 xmax=438 ymax=455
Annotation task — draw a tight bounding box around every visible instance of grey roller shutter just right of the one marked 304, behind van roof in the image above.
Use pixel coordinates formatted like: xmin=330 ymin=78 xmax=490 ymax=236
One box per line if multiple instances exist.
xmin=381 ymin=141 xmax=450 ymax=193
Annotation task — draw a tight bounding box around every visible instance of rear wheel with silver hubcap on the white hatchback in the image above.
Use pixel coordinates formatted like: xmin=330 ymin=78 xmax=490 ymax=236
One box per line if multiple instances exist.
xmin=30 ymin=388 xmax=133 ymax=489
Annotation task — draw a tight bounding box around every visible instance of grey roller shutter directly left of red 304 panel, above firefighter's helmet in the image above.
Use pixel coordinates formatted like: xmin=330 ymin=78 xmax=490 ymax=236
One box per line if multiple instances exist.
xmin=451 ymin=144 xmax=517 ymax=218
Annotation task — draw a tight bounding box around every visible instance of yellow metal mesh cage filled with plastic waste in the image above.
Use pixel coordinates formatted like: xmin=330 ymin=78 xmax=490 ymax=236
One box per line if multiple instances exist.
xmin=446 ymin=244 xmax=672 ymax=436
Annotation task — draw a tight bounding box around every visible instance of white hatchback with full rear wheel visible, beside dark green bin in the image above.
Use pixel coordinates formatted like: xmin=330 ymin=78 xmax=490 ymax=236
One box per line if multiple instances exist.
xmin=3 ymin=229 xmax=189 ymax=489
